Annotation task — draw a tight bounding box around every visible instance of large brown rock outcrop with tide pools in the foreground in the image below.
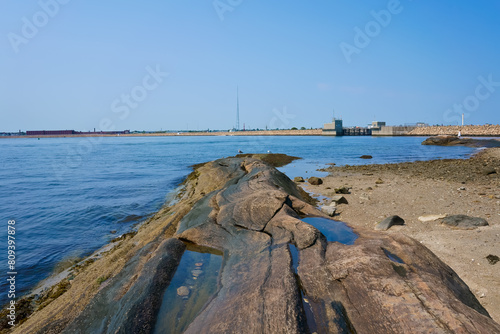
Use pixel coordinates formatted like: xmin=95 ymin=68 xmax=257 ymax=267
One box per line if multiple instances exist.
xmin=15 ymin=158 xmax=500 ymax=334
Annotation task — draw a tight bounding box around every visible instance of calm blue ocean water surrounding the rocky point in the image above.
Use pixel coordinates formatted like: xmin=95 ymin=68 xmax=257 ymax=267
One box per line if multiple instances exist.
xmin=0 ymin=136 xmax=474 ymax=304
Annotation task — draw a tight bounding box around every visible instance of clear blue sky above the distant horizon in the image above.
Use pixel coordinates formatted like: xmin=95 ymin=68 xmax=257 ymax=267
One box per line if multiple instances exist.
xmin=0 ymin=0 xmax=500 ymax=131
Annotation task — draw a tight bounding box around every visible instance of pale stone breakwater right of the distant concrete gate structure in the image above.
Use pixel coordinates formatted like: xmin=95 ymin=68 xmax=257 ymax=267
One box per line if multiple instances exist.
xmin=408 ymin=125 xmax=500 ymax=137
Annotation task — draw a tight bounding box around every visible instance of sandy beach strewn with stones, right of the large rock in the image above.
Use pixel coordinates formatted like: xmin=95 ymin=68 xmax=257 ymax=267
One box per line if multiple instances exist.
xmin=302 ymin=148 xmax=500 ymax=322
